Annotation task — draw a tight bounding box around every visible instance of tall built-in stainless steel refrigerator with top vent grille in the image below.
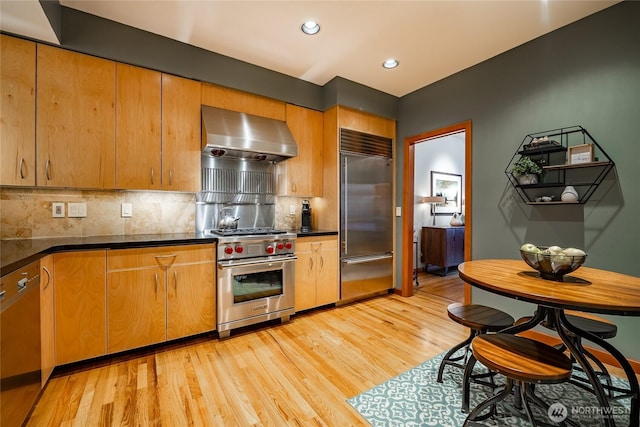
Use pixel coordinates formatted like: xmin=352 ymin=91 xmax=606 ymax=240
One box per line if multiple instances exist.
xmin=340 ymin=129 xmax=393 ymax=302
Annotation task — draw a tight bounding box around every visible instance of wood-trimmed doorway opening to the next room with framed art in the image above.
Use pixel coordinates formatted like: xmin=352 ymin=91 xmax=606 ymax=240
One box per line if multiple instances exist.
xmin=401 ymin=121 xmax=472 ymax=302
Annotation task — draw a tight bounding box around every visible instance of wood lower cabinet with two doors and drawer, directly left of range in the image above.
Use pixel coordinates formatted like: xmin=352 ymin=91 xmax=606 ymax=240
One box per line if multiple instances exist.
xmin=107 ymin=245 xmax=215 ymax=353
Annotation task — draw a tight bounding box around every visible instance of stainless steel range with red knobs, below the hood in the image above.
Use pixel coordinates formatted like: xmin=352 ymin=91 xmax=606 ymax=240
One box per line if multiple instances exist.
xmin=209 ymin=229 xmax=297 ymax=338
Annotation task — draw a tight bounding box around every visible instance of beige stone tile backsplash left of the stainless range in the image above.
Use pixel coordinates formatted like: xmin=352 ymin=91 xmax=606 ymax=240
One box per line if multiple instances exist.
xmin=0 ymin=188 xmax=195 ymax=239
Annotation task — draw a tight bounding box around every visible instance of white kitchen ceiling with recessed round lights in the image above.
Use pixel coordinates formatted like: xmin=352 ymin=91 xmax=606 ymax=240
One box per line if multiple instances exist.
xmin=1 ymin=0 xmax=619 ymax=97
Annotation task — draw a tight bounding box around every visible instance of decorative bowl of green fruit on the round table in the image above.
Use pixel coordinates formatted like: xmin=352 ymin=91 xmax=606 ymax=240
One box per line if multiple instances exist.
xmin=520 ymin=243 xmax=587 ymax=282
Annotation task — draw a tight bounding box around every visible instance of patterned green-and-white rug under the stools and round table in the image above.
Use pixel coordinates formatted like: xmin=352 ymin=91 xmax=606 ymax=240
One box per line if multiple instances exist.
xmin=347 ymin=353 xmax=631 ymax=427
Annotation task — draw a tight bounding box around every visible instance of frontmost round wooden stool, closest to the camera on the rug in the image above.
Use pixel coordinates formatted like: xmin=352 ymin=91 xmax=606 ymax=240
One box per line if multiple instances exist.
xmin=463 ymin=334 xmax=575 ymax=426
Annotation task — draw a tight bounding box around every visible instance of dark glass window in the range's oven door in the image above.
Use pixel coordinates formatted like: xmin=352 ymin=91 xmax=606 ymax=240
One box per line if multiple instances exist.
xmin=233 ymin=268 xmax=283 ymax=304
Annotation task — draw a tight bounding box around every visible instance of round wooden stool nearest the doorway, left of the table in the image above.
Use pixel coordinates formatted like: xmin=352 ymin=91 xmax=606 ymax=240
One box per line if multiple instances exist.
xmin=438 ymin=303 xmax=513 ymax=383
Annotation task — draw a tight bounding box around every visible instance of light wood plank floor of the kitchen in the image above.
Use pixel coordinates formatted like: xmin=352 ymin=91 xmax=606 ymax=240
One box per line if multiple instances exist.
xmin=27 ymin=273 xmax=636 ymax=426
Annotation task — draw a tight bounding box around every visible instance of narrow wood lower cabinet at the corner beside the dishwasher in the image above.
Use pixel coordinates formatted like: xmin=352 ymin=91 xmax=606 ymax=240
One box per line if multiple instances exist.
xmin=40 ymin=255 xmax=56 ymax=387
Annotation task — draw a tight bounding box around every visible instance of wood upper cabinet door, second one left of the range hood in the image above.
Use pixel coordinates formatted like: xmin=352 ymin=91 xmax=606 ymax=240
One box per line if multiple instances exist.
xmin=116 ymin=63 xmax=161 ymax=190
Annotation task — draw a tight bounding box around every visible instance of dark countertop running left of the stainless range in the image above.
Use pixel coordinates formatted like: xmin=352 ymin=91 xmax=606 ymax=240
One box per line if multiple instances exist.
xmin=0 ymin=233 xmax=218 ymax=276
